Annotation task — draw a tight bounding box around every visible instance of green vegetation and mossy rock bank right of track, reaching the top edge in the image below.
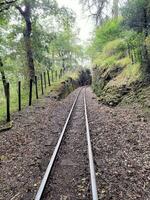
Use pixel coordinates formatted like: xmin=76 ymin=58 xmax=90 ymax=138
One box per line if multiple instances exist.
xmin=87 ymin=0 xmax=150 ymax=106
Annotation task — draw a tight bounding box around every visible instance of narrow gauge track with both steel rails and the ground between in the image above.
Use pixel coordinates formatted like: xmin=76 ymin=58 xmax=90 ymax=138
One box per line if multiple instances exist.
xmin=35 ymin=88 xmax=98 ymax=200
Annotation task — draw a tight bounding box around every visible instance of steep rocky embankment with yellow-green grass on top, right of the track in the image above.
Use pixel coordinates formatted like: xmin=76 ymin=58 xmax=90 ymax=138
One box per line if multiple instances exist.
xmin=93 ymin=39 xmax=150 ymax=107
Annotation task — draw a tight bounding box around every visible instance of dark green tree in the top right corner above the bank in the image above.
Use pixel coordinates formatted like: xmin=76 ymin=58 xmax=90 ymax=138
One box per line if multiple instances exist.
xmin=122 ymin=0 xmax=150 ymax=73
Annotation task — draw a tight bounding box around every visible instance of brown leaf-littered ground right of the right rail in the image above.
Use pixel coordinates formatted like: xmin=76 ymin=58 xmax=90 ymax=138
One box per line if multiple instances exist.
xmin=87 ymin=89 xmax=150 ymax=200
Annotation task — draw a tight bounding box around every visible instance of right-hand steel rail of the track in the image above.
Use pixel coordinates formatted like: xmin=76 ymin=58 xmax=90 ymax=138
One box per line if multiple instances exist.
xmin=84 ymin=89 xmax=98 ymax=200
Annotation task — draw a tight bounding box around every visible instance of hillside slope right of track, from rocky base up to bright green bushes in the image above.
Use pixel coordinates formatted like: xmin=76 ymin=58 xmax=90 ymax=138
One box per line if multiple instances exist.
xmin=89 ymin=19 xmax=150 ymax=111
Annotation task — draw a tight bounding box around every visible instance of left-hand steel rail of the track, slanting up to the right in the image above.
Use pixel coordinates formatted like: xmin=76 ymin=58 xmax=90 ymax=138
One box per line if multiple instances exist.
xmin=35 ymin=89 xmax=82 ymax=200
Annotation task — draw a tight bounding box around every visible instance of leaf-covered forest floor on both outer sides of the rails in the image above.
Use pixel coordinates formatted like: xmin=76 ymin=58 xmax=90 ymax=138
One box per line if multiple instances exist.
xmin=0 ymin=88 xmax=150 ymax=200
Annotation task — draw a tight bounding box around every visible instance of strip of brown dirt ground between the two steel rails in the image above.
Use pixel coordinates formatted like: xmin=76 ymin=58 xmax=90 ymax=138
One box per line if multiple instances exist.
xmin=43 ymin=88 xmax=92 ymax=200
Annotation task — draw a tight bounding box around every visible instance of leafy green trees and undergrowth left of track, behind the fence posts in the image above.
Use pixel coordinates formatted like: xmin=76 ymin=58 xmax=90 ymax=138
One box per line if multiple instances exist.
xmin=0 ymin=0 xmax=83 ymax=122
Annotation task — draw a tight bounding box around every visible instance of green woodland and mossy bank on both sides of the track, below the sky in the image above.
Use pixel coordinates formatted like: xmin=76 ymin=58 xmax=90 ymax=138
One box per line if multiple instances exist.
xmin=0 ymin=0 xmax=150 ymax=118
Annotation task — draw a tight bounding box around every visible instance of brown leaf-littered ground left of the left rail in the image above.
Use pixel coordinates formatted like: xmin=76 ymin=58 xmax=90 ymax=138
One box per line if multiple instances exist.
xmin=0 ymin=90 xmax=78 ymax=200
